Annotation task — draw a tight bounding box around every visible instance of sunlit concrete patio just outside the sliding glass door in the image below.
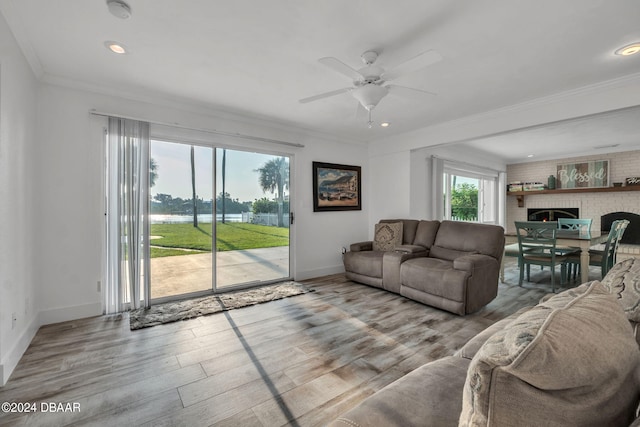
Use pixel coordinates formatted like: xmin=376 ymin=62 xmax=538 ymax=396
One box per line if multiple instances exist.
xmin=151 ymin=246 xmax=289 ymax=298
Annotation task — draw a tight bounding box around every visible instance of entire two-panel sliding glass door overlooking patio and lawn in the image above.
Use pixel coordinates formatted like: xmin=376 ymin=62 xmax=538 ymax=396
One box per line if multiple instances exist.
xmin=149 ymin=140 xmax=290 ymax=300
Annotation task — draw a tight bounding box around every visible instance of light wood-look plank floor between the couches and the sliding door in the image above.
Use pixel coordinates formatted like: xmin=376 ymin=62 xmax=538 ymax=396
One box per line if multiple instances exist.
xmin=0 ymin=268 xmax=547 ymax=427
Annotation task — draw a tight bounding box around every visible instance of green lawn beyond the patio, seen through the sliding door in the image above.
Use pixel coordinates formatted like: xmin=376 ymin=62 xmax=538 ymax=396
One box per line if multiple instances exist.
xmin=151 ymin=222 xmax=289 ymax=258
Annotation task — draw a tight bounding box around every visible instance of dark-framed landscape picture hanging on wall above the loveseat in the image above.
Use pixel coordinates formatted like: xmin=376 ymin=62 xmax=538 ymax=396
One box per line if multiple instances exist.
xmin=313 ymin=162 xmax=362 ymax=212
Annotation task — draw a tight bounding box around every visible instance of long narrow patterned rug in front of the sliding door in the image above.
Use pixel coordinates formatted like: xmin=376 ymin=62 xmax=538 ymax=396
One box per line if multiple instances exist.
xmin=129 ymin=282 xmax=314 ymax=331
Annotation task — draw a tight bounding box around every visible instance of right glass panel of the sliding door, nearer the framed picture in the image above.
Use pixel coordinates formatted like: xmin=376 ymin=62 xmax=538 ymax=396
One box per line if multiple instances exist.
xmin=215 ymin=148 xmax=290 ymax=289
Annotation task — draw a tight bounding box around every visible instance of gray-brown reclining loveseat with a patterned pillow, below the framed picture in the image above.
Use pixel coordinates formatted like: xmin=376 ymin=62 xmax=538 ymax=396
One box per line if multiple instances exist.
xmin=344 ymin=219 xmax=504 ymax=315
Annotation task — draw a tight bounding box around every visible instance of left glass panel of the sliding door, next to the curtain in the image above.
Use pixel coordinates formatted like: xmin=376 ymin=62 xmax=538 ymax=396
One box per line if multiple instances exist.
xmin=149 ymin=141 xmax=214 ymax=298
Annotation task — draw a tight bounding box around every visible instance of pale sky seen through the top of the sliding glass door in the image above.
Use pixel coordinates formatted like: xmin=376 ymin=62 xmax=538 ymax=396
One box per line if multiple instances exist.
xmin=151 ymin=141 xmax=284 ymax=202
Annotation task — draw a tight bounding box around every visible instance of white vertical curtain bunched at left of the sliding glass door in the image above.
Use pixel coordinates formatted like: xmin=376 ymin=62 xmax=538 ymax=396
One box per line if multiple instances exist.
xmin=105 ymin=117 xmax=149 ymax=314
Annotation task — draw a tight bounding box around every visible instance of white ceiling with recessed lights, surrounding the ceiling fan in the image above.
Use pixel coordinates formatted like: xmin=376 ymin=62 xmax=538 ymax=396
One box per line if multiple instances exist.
xmin=0 ymin=0 xmax=640 ymax=160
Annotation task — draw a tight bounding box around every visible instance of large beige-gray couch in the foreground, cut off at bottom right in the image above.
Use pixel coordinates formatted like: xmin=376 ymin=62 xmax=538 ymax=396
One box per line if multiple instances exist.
xmin=330 ymin=259 xmax=640 ymax=427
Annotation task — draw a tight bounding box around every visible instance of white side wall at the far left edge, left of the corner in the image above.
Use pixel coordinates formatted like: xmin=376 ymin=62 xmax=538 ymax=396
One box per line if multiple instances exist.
xmin=0 ymin=14 xmax=40 ymax=385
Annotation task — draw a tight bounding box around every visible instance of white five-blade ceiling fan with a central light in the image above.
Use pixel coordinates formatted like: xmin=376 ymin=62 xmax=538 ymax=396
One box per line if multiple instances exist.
xmin=300 ymin=50 xmax=442 ymax=127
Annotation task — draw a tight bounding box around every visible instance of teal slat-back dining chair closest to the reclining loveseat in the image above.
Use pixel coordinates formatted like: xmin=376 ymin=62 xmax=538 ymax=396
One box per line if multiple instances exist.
xmin=515 ymin=221 xmax=568 ymax=292
